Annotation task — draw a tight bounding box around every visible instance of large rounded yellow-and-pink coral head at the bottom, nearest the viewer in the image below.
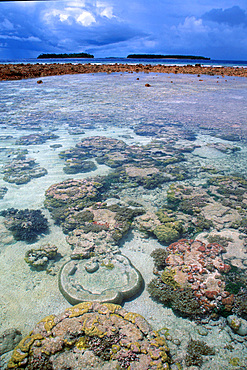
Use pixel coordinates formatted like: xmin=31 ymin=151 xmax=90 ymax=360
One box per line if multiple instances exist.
xmin=8 ymin=302 xmax=169 ymax=370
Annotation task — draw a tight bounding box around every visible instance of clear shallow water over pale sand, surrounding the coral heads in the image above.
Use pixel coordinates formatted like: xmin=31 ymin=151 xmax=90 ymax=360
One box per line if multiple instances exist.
xmin=0 ymin=73 xmax=247 ymax=370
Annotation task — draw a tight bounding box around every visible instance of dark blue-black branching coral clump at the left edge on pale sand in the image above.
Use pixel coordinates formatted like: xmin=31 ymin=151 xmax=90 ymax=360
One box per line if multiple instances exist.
xmin=1 ymin=208 xmax=48 ymax=242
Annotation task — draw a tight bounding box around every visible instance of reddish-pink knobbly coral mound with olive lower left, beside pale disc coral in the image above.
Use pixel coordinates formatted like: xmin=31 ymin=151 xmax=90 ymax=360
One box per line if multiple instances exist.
xmin=148 ymin=239 xmax=246 ymax=317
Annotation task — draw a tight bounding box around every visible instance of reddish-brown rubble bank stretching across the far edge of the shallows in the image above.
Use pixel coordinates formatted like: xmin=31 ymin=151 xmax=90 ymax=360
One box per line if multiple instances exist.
xmin=0 ymin=63 xmax=247 ymax=81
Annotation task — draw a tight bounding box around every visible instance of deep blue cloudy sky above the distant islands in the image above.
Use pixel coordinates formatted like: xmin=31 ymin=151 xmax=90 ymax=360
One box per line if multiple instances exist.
xmin=0 ymin=0 xmax=247 ymax=61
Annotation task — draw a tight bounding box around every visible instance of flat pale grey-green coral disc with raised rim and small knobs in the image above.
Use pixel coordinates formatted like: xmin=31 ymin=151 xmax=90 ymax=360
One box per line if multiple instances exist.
xmin=59 ymin=254 xmax=143 ymax=304
